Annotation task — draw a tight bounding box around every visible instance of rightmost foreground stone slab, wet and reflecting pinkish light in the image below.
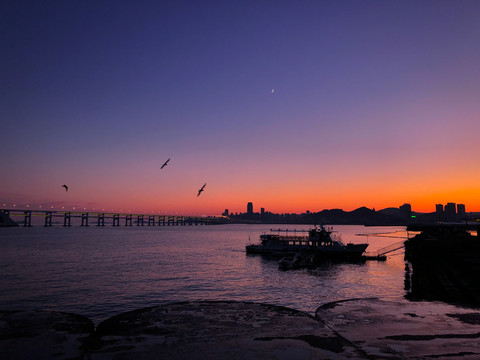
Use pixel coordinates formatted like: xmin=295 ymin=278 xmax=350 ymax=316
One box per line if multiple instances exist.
xmin=316 ymin=299 xmax=480 ymax=360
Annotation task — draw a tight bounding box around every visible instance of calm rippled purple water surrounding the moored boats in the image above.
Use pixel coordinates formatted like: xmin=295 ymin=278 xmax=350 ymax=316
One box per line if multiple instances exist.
xmin=0 ymin=225 xmax=406 ymax=323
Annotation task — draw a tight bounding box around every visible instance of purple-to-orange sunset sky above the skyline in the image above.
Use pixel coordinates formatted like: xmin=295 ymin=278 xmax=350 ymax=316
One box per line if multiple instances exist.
xmin=0 ymin=0 xmax=480 ymax=215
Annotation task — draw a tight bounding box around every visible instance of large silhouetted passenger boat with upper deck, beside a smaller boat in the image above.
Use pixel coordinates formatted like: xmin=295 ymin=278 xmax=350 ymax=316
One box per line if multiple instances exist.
xmin=246 ymin=226 xmax=368 ymax=260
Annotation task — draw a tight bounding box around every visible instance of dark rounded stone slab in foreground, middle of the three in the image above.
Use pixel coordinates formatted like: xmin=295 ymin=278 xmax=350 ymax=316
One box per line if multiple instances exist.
xmin=90 ymin=301 xmax=364 ymax=360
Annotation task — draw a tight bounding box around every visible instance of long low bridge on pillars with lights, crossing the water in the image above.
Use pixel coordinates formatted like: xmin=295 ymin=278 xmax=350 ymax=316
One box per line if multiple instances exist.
xmin=0 ymin=209 xmax=226 ymax=227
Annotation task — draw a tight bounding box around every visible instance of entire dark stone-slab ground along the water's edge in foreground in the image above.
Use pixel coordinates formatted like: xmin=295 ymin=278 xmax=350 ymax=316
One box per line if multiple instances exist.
xmin=0 ymin=299 xmax=480 ymax=360
